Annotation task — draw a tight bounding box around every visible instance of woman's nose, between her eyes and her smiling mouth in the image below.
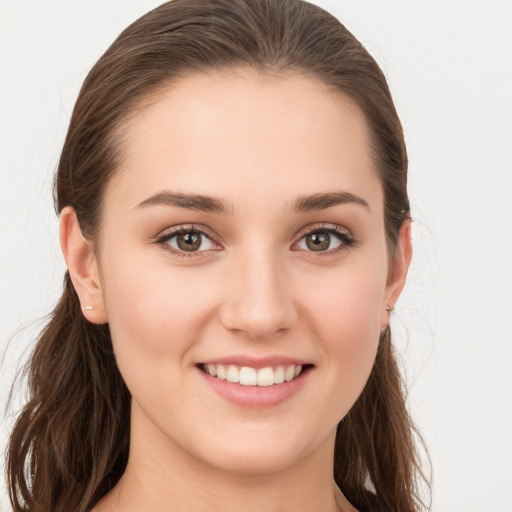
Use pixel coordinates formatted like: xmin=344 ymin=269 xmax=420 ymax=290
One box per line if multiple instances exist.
xmin=220 ymin=250 xmax=298 ymax=340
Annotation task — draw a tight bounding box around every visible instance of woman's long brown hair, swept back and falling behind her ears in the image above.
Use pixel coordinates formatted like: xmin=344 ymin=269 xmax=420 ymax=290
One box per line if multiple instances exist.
xmin=7 ymin=0 xmax=432 ymax=512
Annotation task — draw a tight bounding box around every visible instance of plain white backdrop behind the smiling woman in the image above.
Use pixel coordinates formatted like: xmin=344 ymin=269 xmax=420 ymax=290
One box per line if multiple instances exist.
xmin=0 ymin=0 xmax=512 ymax=512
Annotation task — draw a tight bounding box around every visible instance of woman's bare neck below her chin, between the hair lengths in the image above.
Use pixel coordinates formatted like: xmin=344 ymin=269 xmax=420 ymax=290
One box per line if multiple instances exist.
xmin=94 ymin=404 xmax=355 ymax=512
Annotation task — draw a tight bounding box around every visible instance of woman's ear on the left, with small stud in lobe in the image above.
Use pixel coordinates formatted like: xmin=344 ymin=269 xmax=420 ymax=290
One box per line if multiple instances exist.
xmin=60 ymin=206 xmax=108 ymax=324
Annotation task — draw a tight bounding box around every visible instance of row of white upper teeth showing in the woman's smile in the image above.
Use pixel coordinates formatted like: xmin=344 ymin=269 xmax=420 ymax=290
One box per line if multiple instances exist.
xmin=203 ymin=364 xmax=302 ymax=387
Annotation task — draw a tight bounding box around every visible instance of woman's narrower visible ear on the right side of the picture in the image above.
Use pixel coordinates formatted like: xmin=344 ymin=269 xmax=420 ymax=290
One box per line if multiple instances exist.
xmin=381 ymin=220 xmax=412 ymax=329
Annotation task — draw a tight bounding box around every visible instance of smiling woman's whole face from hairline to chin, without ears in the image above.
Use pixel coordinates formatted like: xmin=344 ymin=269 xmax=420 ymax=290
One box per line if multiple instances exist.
xmin=89 ymin=70 xmax=400 ymax=473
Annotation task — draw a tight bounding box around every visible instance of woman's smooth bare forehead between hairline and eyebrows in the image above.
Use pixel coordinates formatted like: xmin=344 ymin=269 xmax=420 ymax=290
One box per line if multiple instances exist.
xmin=107 ymin=69 xmax=382 ymax=214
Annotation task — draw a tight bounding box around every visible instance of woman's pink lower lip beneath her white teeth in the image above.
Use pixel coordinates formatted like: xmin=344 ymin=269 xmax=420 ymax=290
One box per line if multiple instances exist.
xmin=197 ymin=368 xmax=311 ymax=408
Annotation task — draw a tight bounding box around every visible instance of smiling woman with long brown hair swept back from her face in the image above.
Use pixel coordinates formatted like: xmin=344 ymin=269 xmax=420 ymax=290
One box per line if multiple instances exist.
xmin=8 ymin=0 xmax=432 ymax=512
